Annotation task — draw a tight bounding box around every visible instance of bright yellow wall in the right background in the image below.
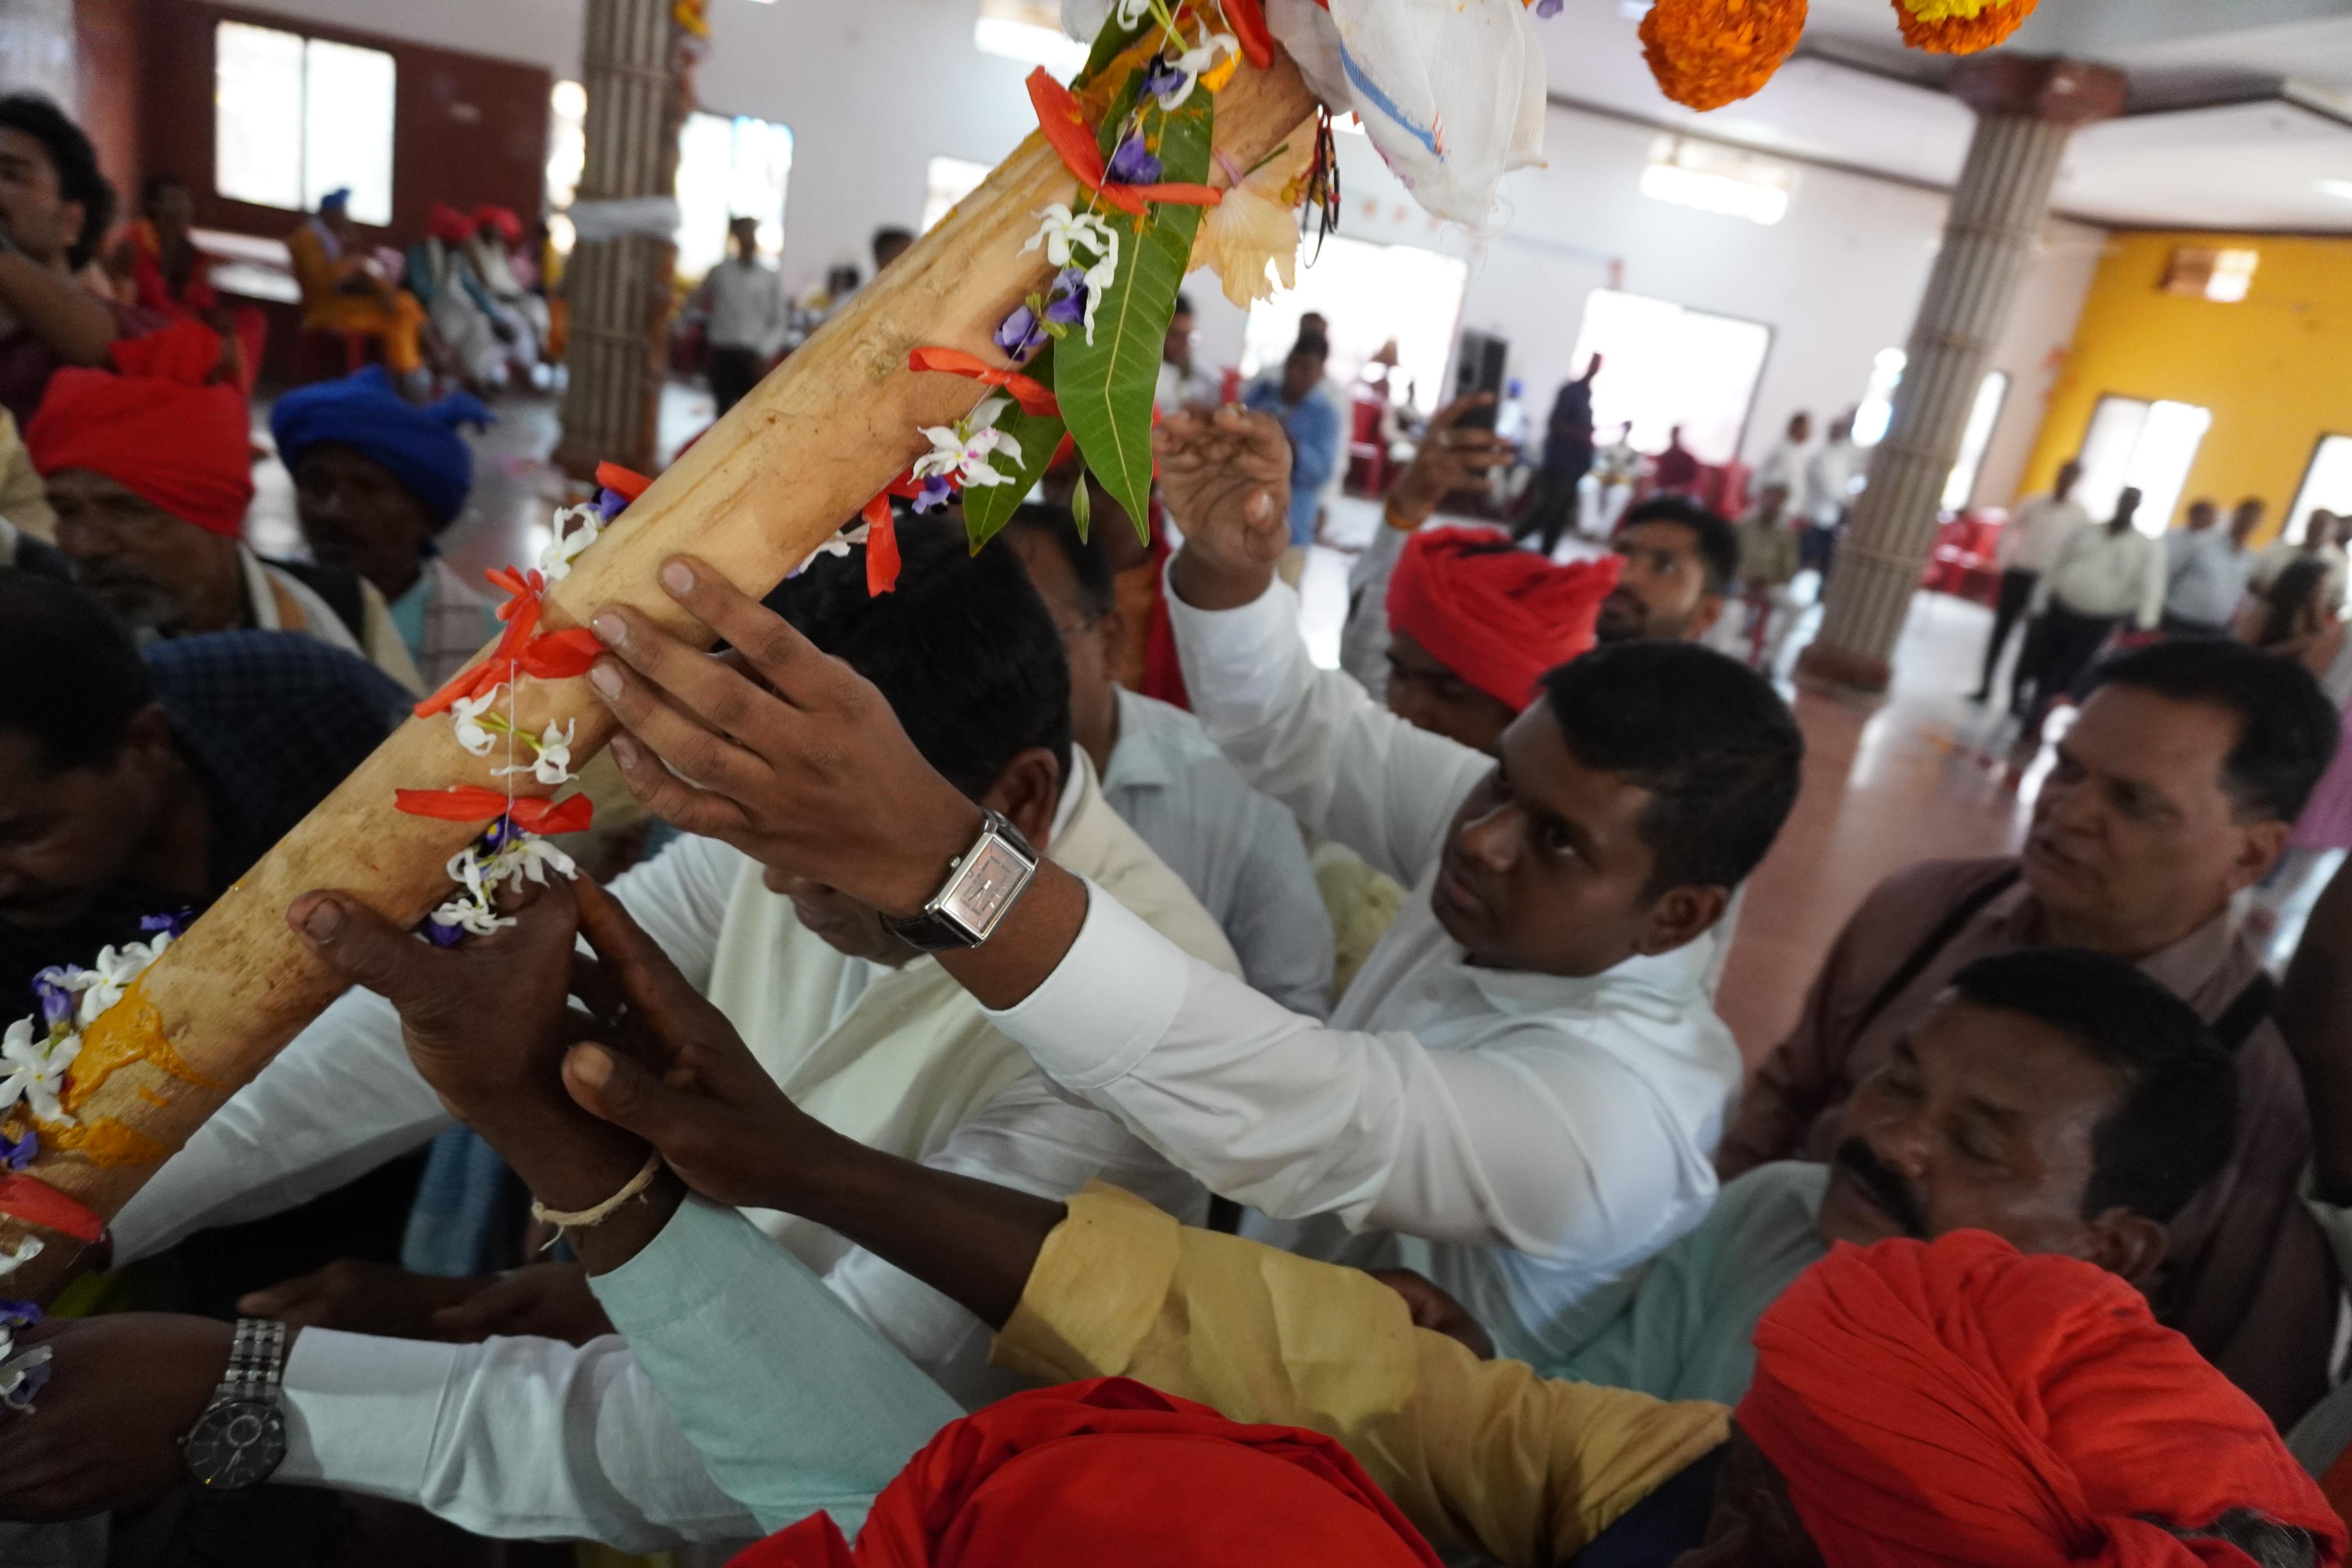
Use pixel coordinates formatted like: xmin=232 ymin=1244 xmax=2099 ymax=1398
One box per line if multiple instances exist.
xmin=2025 ymin=233 xmax=2352 ymax=536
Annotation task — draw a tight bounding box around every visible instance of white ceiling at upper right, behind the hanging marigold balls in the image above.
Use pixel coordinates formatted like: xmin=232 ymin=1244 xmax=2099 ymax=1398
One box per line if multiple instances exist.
xmin=1538 ymin=0 xmax=2352 ymax=233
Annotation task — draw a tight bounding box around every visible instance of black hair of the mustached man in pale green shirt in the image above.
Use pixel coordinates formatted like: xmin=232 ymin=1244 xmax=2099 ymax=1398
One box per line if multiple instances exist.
xmin=1952 ymin=947 xmax=2237 ymax=1220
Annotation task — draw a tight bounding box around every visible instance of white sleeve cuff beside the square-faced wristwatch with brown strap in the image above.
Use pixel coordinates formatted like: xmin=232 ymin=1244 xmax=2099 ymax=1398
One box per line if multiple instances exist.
xmin=988 ymin=879 xmax=1185 ymax=1093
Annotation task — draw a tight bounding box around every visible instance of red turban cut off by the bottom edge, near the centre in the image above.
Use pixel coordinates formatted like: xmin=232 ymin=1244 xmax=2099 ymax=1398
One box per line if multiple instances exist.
xmin=732 ymin=1378 xmax=1437 ymax=1568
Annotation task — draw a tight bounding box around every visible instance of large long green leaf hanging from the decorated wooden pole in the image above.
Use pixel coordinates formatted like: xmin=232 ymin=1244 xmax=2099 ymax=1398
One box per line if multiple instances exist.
xmin=1054 ymin=92 xmax=1214 ymax=541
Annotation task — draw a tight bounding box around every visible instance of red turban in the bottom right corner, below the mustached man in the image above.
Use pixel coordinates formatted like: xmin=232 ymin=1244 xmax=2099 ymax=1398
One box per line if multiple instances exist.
xmin=1738 ymin=1229 xmax=2345 ymax=1568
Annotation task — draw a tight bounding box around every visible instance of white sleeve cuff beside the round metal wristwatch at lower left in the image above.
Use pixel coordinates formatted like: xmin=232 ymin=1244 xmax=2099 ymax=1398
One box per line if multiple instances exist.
xmin=275 ymin=1328 xmax=459 ymax=1502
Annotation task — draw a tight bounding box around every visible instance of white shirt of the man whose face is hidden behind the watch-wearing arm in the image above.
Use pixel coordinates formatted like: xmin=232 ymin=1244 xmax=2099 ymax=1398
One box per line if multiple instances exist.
xmin=115 ymin=755 xmax=1239 ymax=1552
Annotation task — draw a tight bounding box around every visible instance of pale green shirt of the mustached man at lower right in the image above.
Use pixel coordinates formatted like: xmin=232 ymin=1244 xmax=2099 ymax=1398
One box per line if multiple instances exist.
xmin=1536 ymin=1159 xmax=1830 ymax=1406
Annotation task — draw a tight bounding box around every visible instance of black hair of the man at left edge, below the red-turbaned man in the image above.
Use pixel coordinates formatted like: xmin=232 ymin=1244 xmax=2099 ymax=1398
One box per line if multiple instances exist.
xmin=0 ymin=566 xmax=155 ymax=769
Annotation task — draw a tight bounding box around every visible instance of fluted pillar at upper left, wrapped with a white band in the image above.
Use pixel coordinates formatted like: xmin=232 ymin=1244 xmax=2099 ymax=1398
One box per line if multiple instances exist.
xmin=555 ymin=0 xmax=687 ymax=477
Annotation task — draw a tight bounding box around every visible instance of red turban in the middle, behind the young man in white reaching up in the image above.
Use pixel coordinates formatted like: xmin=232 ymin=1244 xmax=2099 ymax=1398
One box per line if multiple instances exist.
xmin=1387 ymin=529 xmax=1618 ymax=712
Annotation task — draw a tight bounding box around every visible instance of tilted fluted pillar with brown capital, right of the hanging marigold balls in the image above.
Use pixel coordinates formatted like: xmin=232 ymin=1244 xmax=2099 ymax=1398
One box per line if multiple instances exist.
xmin=1797 ymin=54 xmax=2126 ymax=691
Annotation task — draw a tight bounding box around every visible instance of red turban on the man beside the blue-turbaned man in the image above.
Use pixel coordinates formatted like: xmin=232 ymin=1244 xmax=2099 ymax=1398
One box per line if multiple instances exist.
xmin=24 ymin=322 xmax=254 ymax=538
